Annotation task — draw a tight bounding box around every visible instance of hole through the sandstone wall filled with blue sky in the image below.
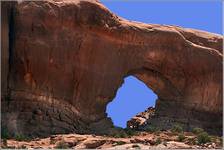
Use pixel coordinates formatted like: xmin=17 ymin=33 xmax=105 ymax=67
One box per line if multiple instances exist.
xmin=106 ymin=76 xmax=158 ymax=128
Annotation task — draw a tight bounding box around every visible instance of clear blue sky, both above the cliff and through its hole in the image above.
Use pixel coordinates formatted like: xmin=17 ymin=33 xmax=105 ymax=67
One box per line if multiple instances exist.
xmin=101 ymin=0 xmax=222 ymax=127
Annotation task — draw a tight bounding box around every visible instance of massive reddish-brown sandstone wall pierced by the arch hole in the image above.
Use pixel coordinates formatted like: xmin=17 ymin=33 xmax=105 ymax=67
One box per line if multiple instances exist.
xmin=2 ymin=0 xmax=223 ymax=135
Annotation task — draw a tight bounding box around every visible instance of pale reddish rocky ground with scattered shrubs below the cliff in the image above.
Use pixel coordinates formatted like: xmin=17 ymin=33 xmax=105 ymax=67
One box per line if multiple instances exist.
xmin=1 ymin=131 xmax=222 ymax=149
